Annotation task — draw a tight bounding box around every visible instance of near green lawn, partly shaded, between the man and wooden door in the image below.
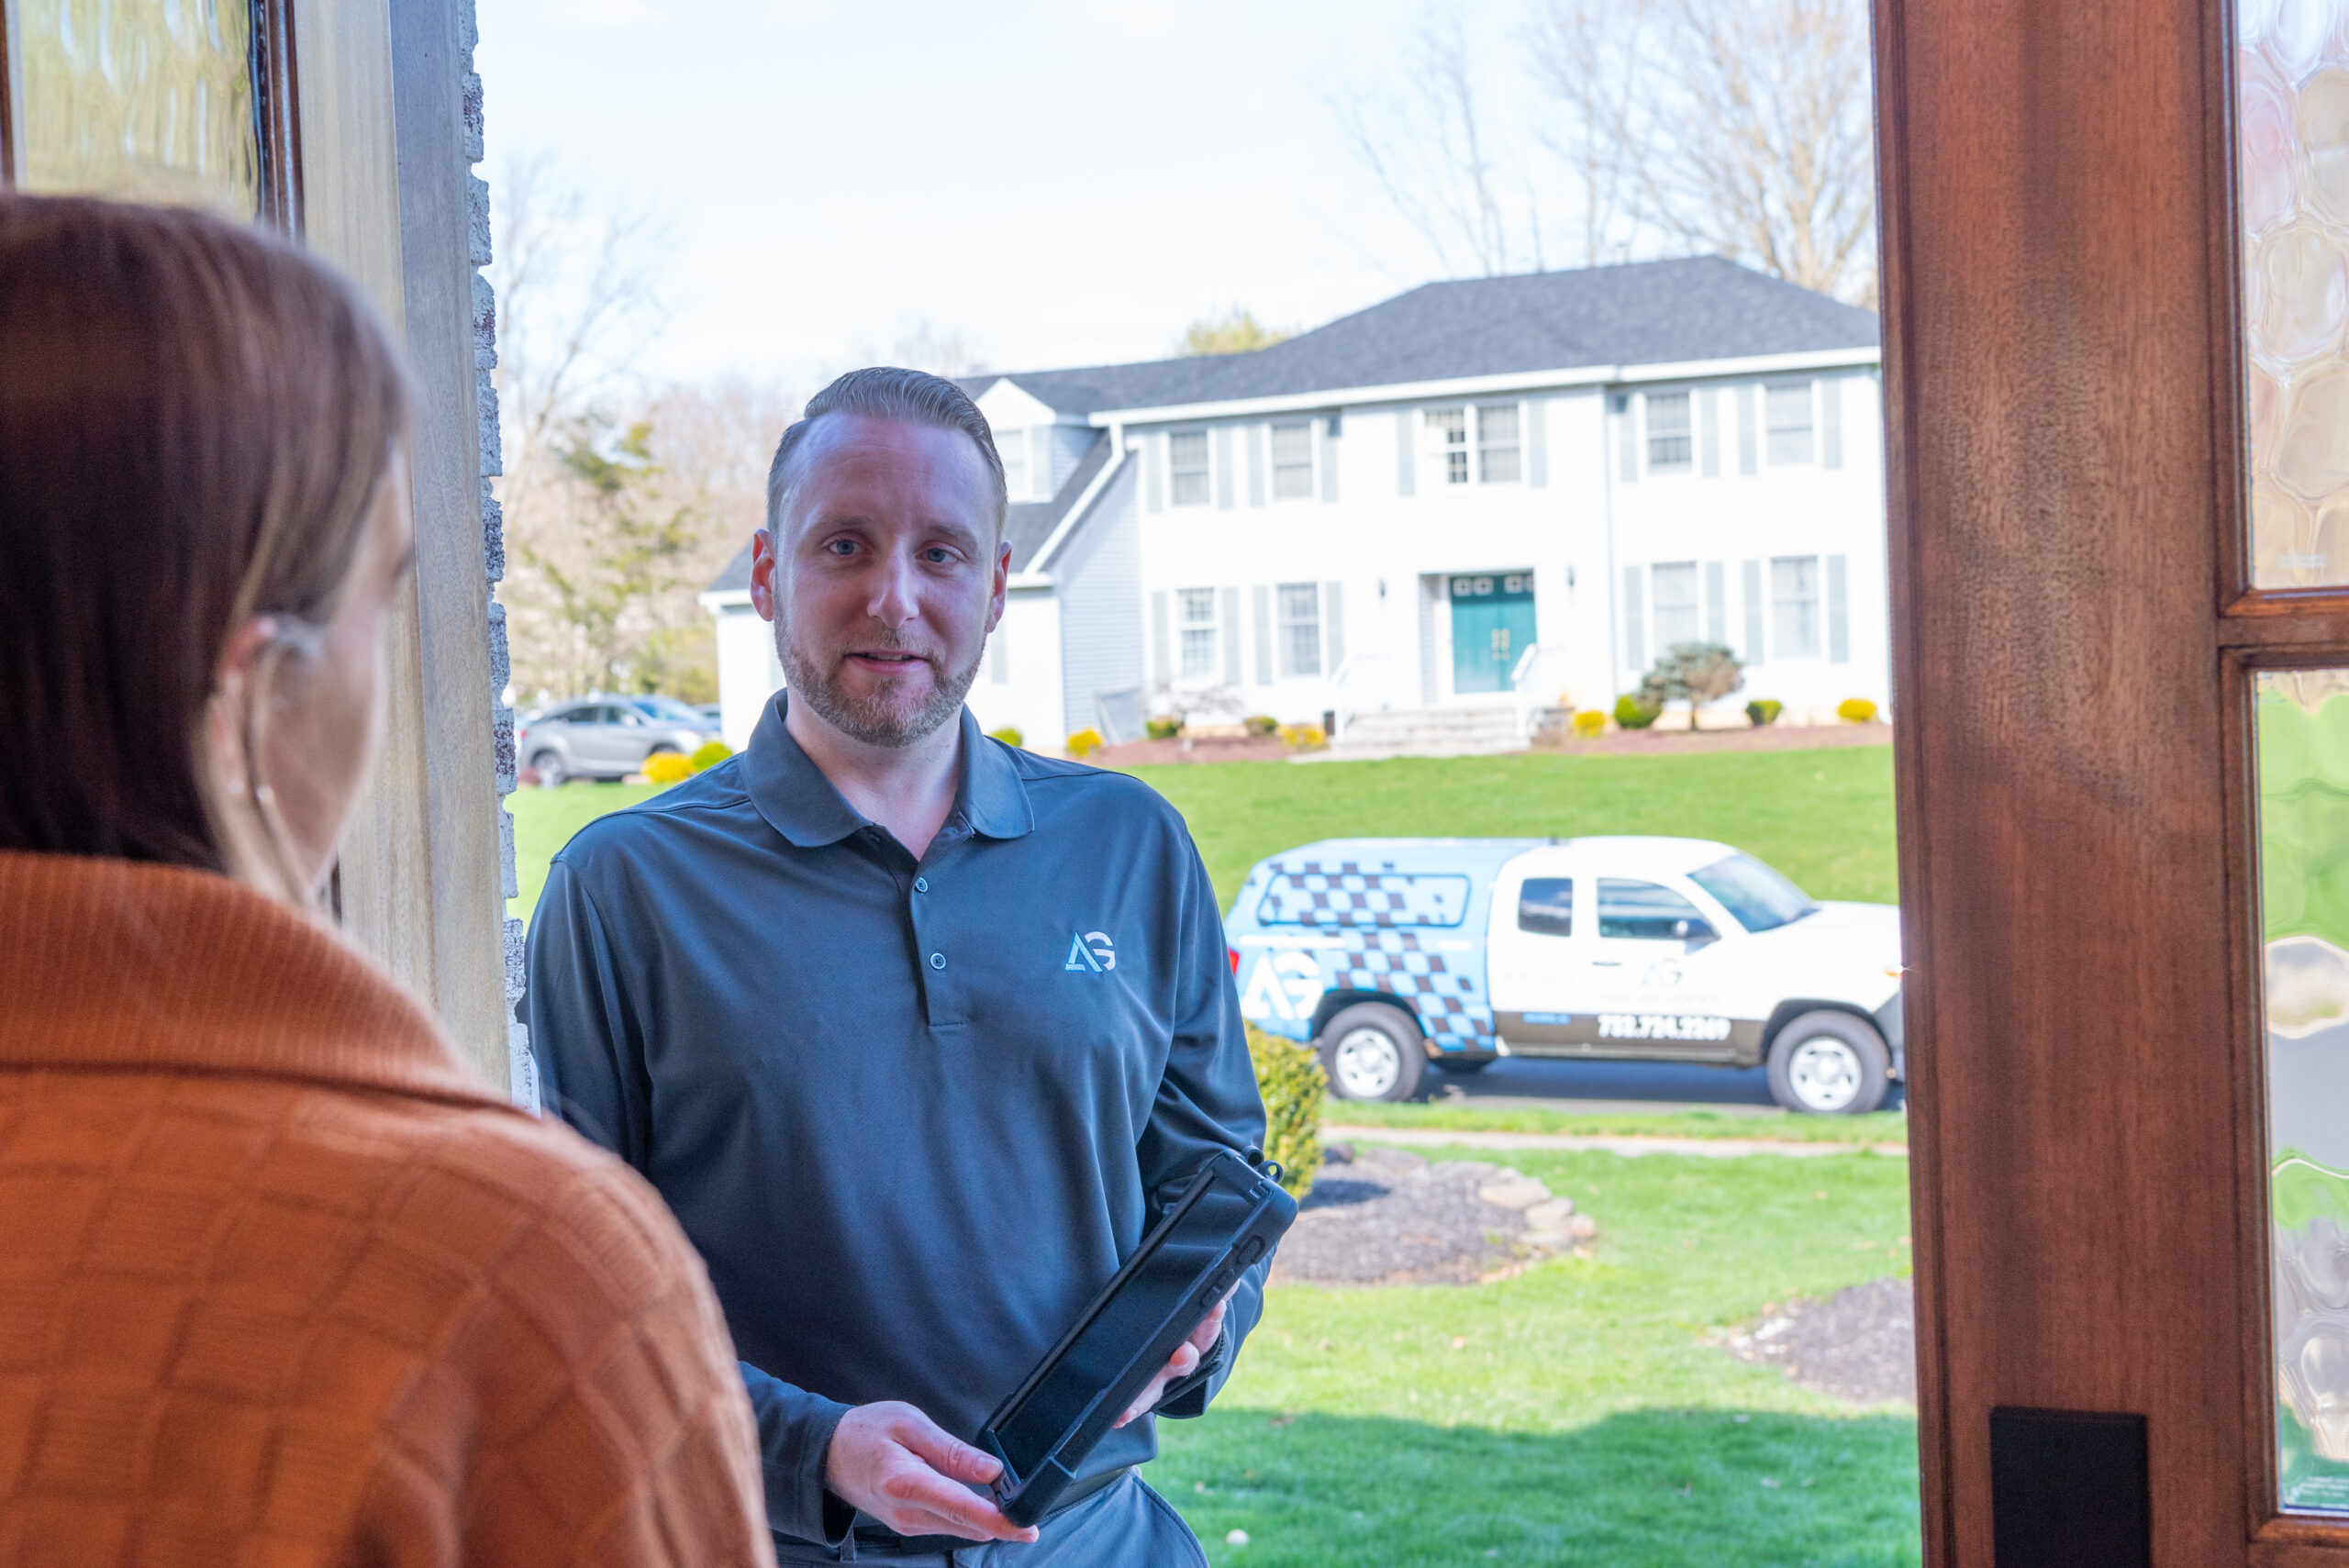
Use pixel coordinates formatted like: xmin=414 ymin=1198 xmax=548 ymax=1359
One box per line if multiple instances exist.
xmin=1149 ymin=1151 xmax=1920 ymax=1568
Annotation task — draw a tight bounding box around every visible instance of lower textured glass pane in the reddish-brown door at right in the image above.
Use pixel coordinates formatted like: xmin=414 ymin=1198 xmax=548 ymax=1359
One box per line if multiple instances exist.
xmin=2257 ymin=669 xmax=2349 ymax=1514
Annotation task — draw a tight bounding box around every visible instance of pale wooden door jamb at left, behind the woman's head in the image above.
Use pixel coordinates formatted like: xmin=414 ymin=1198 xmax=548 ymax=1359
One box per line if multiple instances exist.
xmin=0 ymin=0 xmax=519 ymax=1089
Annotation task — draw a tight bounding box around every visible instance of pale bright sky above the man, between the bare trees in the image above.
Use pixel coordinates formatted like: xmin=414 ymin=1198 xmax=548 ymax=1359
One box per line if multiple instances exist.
xmin=477 ymin=0 xmax=1465 ymax=383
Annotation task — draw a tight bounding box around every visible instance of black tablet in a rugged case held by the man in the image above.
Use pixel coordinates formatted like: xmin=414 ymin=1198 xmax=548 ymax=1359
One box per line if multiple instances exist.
xmin=977 ymin=1151 xmax=1297 ymax=1526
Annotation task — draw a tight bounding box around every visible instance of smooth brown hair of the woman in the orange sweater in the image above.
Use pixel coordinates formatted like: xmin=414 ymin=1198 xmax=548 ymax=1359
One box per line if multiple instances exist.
xmin=0 ymin=197 xmax=406 ymax=871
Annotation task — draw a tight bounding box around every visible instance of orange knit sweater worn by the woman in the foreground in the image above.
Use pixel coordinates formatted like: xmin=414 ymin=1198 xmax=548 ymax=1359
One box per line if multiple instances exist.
xmin=0 ymin=852 xmax=773 ymax=1568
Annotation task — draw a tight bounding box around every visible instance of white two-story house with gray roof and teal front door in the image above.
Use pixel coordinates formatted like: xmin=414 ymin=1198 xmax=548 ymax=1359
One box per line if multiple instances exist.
xmin=702 ymin=258 xmax=1891 ymax=749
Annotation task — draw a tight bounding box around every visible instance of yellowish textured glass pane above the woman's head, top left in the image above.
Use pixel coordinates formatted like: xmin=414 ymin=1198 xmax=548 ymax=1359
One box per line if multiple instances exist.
xmin=9 ymin=0 xmax=261 ymax=218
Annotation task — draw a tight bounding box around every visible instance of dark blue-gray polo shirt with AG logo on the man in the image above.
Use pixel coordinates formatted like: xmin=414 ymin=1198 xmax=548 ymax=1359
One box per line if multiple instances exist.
xmin=529 ymin=697 xmax=1264 ymax=1542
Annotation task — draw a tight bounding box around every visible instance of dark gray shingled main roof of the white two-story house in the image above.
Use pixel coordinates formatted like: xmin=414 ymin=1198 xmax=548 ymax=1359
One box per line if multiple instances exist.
xmin=963 ymin=256 xmax=1879 ymax=413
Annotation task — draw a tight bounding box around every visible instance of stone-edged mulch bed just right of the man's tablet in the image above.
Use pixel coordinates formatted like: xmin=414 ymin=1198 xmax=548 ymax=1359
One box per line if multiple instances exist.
xmin=1274 ymin=1143 xmax=1595 ymax=1284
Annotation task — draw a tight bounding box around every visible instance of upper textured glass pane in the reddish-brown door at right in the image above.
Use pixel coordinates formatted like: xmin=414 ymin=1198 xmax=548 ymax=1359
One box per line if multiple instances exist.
xmin=2236 ymin=0 xmax=2349 ymax=587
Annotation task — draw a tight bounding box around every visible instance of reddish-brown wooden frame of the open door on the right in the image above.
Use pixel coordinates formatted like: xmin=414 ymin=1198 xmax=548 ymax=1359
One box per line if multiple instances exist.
xmin=1875 ymin=0 xmax=2349 ymax=1568
